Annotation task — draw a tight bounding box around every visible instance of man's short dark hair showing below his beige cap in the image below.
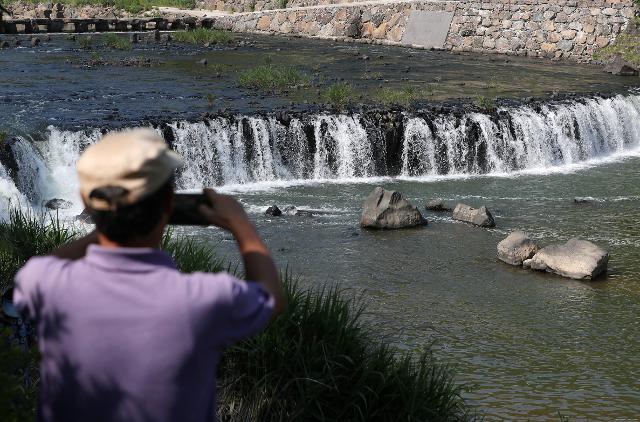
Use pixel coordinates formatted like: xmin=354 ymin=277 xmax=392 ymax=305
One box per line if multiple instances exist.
xmin=89 ymin=179 xmax=173 ymax=243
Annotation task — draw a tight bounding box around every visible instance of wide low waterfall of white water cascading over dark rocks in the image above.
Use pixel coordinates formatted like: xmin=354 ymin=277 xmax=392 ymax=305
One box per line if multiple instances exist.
xmin=0 ymin=93 xmax=640 ymax=217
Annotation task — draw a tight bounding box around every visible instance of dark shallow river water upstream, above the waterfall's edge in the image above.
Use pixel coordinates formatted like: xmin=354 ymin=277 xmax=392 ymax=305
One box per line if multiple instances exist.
xmin=0 ymin=35 xmax=640 ymax=131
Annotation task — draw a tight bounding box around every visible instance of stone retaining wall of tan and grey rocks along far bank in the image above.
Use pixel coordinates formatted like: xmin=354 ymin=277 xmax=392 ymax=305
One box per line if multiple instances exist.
xmin=205 ymin=0 xmax=635 ymax=62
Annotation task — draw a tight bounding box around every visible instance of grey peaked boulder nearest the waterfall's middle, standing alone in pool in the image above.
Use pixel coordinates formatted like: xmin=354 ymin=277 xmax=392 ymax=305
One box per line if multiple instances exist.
xmin=360 ymin=186 xmax=427 ymax=229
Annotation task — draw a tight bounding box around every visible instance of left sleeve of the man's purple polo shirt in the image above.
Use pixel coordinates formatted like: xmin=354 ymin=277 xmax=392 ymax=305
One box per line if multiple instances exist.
xmin=13 ymin=256 xmax=67 ymax=319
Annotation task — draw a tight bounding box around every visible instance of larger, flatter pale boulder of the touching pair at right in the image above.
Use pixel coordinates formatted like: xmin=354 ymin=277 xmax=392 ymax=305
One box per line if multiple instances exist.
xmin=523 ymin=238 xmax=609 ymax=280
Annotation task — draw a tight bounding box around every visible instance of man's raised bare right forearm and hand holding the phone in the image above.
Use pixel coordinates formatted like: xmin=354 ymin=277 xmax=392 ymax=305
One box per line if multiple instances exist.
xmin=199 ymin=189 xmax=285 ymax=317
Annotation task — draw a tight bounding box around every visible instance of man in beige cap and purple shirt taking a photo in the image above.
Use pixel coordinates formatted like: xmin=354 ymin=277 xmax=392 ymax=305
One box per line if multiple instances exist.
xmin=14 ymin=130 xmax=284 ymax=422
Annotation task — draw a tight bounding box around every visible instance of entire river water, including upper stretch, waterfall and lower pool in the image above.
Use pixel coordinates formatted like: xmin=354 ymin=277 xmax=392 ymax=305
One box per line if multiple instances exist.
xmin=0 ymin=33 xmax=640 ymax=420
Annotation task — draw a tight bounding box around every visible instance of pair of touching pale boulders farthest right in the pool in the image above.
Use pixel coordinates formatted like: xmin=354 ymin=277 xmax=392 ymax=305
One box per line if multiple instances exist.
xmin=498 ymin=231 xmax=609 ymax=280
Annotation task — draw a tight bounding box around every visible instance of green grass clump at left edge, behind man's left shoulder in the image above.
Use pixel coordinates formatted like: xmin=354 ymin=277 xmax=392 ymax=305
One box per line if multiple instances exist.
xmin=0 ymin=208 xmax=77 ymax=294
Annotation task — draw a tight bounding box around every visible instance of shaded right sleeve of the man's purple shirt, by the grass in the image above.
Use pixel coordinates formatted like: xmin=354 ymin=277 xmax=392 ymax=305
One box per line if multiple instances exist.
xmin=222 ymin=277 xmax=275 ymax=342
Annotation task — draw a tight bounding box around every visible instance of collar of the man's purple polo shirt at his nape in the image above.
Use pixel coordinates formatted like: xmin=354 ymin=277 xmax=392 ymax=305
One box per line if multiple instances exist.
xmin=85 ymin=245 xmax=176 ymax=272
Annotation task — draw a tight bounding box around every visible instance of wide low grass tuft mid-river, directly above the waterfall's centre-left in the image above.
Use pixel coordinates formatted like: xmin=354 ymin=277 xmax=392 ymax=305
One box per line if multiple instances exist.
xmin=238 ymin=62 xmax=309 ymax=92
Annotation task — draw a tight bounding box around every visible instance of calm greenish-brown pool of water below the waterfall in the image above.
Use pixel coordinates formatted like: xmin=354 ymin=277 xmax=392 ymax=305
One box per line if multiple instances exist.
xmin=190 ymin=157 xmax=640 ymax=420
